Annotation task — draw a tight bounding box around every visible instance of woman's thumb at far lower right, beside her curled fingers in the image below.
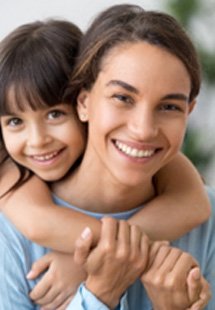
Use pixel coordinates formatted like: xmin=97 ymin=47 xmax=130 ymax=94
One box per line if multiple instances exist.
xmin=187 ymin=267 xmax=202 ymax=304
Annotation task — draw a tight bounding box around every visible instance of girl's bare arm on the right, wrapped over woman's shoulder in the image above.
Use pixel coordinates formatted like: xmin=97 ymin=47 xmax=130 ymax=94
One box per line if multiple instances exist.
xmin=129 ymin=153 xmax=210 ymax=240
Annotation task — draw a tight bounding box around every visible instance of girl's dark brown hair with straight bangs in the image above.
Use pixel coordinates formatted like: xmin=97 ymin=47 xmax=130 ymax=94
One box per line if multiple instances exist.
xmin=0 ymin=20 xmax=82 ymax=194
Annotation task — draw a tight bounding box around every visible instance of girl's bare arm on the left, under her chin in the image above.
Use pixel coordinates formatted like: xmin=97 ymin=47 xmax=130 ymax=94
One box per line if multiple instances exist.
xmin=0 ymin=163 xmax=101 ymax=253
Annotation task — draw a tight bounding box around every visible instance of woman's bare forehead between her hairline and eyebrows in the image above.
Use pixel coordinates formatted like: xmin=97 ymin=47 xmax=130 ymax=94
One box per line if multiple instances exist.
xmin=98 ymin=42 xmax=191 ymax=93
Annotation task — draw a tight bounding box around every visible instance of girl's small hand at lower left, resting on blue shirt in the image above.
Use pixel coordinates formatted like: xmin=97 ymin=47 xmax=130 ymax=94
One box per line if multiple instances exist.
xmin=27 ymin=252 xmax=86 ymax=310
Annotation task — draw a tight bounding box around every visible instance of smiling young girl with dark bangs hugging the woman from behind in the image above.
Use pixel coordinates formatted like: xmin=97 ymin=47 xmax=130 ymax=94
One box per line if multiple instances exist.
xmin=0 ymin=13 xmax=208 ymax=308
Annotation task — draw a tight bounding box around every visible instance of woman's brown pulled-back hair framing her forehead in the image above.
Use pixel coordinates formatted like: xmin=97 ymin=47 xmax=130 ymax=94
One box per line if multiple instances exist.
xmin=65 ymin=4 xmax=201 ymax=102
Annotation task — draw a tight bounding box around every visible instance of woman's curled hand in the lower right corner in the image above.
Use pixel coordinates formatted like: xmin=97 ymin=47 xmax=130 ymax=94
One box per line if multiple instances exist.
xmin=141 ymin=243 xmax=210 ymax=310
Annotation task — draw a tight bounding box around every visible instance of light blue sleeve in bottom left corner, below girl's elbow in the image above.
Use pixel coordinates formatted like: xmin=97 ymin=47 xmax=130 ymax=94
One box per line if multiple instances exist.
xmin=0 ymin=232 xmax=37 ymax=310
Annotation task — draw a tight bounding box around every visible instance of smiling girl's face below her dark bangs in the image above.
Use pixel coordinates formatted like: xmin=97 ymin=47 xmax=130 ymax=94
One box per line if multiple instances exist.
xmin=1 ymin=99 xmax=84 ymax=181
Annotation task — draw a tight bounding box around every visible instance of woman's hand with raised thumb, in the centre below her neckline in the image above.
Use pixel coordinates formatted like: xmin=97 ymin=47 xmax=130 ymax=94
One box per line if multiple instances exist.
xmin=74 ymin=218 xmax=149 ymax=309
